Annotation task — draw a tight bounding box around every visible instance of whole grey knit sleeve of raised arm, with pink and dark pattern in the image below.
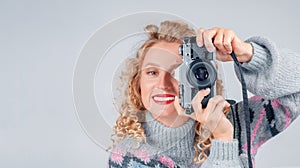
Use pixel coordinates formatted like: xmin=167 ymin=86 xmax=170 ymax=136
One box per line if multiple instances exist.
xmin=235 ymin=37 xmax=300 ymax=165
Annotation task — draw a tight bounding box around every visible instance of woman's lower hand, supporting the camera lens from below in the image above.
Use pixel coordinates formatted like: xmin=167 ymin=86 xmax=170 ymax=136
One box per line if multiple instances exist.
xmin=175 ymin=89 xmax=233 ymax=141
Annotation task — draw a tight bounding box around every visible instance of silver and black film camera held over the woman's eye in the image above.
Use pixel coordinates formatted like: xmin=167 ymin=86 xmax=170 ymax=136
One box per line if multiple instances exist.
xmin=175 ymin=37 xmax=217 ymax=114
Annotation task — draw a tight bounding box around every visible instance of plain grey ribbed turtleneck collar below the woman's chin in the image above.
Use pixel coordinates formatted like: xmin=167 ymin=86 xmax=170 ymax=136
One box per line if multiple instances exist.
xmin=143 ymin=112 xmax=195 ymax=165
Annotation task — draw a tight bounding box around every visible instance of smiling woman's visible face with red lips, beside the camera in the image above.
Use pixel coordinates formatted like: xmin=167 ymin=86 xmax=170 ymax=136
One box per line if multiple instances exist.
xmin=140 ymin=41 xmax=186 ymax=122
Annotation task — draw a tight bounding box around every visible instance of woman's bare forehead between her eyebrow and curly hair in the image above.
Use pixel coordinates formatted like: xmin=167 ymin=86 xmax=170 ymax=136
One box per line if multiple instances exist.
xmin=142 ymin=42 xmax=182 ymax=71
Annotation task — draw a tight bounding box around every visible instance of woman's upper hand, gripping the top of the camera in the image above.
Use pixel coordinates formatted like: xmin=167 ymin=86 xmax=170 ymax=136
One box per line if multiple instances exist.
xmin=197 ymin=27 xmax=253 ymax=62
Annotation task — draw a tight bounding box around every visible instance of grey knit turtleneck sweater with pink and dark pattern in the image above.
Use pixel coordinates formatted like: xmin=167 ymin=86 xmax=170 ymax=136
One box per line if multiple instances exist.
xmin=109 ymin=37 xmax=300 ymax=168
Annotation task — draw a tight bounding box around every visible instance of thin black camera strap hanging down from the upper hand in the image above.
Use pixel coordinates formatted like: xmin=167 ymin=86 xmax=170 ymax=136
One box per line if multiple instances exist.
xmin=230 ymin=52 xmax=253 ymax=168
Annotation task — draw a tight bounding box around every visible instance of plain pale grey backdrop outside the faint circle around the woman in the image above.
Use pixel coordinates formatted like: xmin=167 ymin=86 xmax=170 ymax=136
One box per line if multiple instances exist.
xmin=0 ymin=0 xmax=300 ymax=168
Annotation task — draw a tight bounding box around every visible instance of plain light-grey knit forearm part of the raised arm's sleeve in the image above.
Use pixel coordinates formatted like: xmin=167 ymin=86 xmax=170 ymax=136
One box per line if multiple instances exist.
xmin=235 ymin=36 xmax=300 ymax=99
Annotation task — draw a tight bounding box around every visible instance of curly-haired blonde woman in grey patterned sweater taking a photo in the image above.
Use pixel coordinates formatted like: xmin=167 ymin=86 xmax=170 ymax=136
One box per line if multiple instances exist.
xmin=109 ymin=21 xmax=300 ymax=168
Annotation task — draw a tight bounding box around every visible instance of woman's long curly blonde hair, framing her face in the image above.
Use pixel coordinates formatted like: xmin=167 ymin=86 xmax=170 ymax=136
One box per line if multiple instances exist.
xmin=112 ymin=21 xmax=226 ymax=163
